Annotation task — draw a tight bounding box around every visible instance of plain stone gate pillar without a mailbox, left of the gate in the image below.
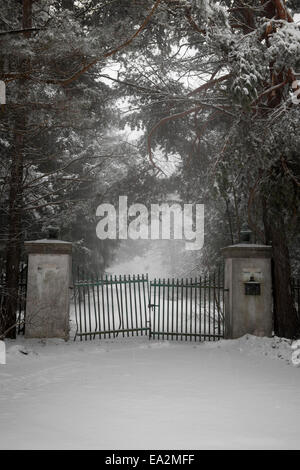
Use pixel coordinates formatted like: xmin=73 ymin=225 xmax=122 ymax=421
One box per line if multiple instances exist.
xmin=25 ymin=239 xmax=72 ymax=340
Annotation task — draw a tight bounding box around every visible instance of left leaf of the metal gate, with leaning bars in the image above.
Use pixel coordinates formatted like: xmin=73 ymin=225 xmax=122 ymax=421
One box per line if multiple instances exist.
xmin=74 ymin=275 xmax=150 ymax=339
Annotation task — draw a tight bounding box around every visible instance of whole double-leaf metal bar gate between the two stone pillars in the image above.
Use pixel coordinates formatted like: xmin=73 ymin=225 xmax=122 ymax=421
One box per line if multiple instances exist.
xmin=74 ymin=272 xmax=227 ymax=341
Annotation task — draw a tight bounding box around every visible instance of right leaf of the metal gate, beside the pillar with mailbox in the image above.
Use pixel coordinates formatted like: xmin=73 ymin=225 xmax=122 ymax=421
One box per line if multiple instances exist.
xmin=150 ymin=274 xmax=226 ymax=341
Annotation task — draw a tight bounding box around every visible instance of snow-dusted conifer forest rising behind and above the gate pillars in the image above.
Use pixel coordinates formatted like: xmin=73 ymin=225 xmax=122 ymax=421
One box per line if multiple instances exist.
xmin=0 ymin=0 xmax=300 ymax=338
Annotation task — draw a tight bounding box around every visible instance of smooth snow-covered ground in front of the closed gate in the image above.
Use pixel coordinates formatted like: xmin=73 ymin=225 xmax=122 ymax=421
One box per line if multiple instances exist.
xmin=0 ymin=336 xmax=300 ymax=449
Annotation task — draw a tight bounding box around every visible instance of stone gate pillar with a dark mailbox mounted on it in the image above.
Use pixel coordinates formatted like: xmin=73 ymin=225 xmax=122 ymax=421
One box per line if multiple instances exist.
xmin=222 ymin=244 xmax=273 ymax=338
